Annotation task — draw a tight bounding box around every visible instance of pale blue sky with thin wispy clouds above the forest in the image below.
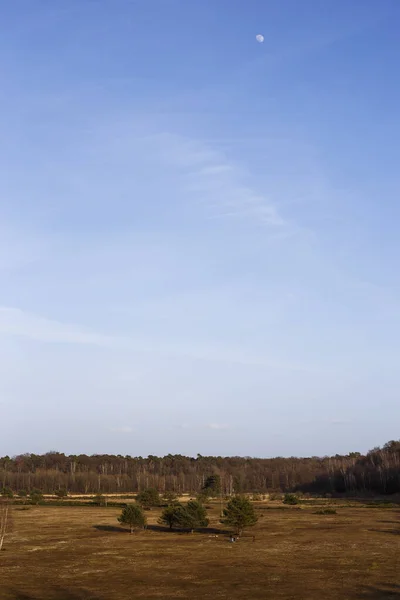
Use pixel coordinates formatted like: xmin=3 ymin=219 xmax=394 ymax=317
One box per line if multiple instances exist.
xmin=0 ymin=0 xmax=400 ymax=456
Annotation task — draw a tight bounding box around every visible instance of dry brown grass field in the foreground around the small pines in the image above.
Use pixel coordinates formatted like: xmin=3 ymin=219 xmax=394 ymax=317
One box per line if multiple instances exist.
xmin=0 ymin=503 xmax=400 ymax=600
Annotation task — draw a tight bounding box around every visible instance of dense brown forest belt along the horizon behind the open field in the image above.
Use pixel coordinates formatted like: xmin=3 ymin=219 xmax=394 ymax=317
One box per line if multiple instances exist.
xmin=0 ymin=440 xmax=400 ymax=495
